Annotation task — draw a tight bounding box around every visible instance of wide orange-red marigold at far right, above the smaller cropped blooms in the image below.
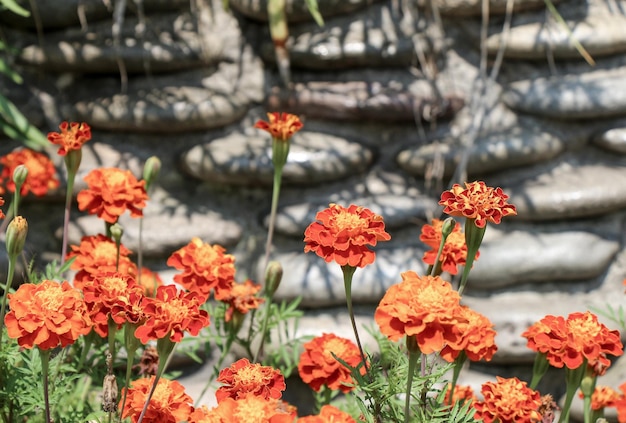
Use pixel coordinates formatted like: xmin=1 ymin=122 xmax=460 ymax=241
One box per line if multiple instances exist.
xmin=522 ymin=312 xmax=623 ymax=374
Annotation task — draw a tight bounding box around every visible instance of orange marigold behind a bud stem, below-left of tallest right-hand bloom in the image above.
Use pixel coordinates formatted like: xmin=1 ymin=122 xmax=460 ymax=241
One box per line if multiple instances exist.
xmin=420 ymin=219 xmax=480 ymax=275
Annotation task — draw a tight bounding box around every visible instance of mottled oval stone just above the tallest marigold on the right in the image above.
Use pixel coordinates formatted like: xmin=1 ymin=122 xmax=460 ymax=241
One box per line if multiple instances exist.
xmin=397 ymin=123 xmax=566 ymax=177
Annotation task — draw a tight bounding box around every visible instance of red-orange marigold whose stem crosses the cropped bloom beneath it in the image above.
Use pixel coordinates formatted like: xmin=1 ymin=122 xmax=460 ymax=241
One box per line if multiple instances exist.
xmin=135 ymin=285 xmax=209 ymax=344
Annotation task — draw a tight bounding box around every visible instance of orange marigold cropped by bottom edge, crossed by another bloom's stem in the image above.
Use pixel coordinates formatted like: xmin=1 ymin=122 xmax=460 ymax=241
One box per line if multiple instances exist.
xmin=119 ymin=376 xmax=193 ymax=423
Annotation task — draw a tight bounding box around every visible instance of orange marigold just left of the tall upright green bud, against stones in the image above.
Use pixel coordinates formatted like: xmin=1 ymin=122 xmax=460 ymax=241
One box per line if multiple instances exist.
xmin=77 ymin=167 xmax=148 ymax=223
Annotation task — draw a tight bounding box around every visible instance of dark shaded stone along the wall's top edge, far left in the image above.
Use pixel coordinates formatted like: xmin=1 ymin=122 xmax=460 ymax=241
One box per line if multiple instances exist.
xmin=0 ymin=0 xmax=190 ymax=29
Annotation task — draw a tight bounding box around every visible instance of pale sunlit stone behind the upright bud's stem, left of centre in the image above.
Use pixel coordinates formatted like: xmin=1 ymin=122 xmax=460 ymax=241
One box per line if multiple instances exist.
xmin=67 ymin=190 xmax=243 ymax=258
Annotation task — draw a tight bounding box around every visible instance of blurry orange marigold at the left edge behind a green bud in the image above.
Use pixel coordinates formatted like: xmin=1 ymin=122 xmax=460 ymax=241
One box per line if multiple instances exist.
xmin=0 ymin=148 xmax=59 ymax=197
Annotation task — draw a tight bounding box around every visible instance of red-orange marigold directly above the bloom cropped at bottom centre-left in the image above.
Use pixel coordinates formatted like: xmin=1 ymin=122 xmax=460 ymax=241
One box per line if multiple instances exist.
xmin=215 ymin=358 xmax=286 ymax=403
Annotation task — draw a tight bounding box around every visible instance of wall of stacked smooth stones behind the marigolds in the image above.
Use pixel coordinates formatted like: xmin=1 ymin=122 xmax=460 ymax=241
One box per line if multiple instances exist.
xmin=0 ymin=0 xmax=626 ymax=418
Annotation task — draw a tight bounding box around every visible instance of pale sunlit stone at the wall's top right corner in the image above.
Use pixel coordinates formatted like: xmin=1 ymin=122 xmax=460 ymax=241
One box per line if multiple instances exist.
xmin=486 ymin=14 xmax=626 ymax=60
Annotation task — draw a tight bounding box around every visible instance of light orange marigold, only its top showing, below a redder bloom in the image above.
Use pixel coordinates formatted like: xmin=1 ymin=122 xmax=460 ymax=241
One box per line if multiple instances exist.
xmin=189 ymin=395 xmax=296 ymax=423
